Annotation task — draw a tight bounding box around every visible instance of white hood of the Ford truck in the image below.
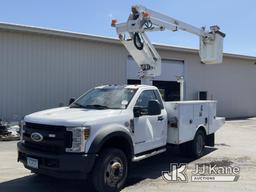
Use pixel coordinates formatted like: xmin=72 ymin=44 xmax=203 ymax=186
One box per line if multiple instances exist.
xmin=24 ymin=107 xmax=122 ymax=126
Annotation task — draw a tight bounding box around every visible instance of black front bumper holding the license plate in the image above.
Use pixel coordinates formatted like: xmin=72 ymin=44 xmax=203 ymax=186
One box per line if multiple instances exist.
xmin=17 ymin=142 xmax=97 ymax=179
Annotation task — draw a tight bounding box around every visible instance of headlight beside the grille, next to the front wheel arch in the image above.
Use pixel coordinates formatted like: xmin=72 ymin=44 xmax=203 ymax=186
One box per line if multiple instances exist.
xmin=66 ymin=127 xmax=90 ymax=153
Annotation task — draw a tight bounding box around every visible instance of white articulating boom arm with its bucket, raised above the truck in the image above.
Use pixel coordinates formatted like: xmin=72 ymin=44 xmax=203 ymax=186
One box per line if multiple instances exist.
xmin=112 ymin=6 xmax=225 ymax=84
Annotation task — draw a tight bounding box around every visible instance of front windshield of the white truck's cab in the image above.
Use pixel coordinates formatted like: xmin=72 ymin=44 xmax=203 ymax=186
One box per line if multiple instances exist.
xmin=70 ymin=87 xmax=137 ymax=109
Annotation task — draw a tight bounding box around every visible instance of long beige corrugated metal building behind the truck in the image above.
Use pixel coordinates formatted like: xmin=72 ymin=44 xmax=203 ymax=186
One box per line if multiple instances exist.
xmin=0 ymin=23 xmax=256 ymax=121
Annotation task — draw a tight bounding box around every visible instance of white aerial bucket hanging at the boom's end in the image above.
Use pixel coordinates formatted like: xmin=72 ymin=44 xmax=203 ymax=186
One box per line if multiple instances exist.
xmin=199 ymin=31 xmax=225 ymax=64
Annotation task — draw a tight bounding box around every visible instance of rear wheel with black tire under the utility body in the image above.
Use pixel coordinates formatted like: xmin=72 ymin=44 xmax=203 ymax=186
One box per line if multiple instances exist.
xmin=190 ymin=129 xmax=205 ymax=158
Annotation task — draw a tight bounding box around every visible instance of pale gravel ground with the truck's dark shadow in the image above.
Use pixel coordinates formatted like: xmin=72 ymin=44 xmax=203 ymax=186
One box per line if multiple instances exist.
xmin=0 ymin=118 xmax=256 ymax=192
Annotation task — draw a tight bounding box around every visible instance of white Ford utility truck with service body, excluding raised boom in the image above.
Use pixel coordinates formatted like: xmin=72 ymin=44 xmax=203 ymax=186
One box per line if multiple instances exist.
xmin=18 ymin=85 xmax=224 ymax=191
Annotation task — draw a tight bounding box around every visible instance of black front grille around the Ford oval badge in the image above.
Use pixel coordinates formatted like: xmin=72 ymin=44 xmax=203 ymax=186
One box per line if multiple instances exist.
xmin=23 ymin=123 xmax=72 ymax=154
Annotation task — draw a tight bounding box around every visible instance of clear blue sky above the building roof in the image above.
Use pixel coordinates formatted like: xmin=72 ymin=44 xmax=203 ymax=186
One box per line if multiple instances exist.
xmin=0 ymin=0 xmax=256 ymax=56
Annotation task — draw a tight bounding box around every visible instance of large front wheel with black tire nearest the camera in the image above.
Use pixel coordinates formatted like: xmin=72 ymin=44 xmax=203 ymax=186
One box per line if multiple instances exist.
xmin=92 ymin=148 xmax=128 ymax=192
